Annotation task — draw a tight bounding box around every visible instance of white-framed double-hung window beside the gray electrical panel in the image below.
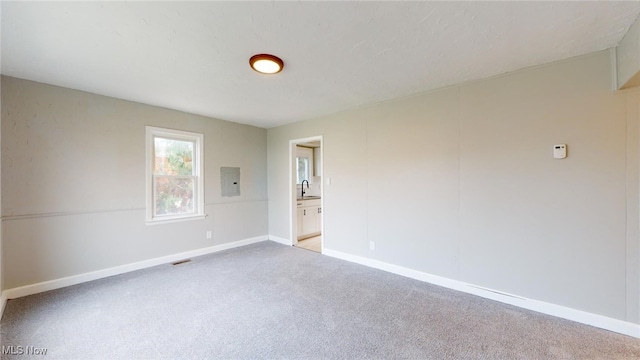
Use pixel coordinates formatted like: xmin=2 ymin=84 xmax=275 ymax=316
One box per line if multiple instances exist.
xmin=147 ymin=126 xmax=204 ymax=223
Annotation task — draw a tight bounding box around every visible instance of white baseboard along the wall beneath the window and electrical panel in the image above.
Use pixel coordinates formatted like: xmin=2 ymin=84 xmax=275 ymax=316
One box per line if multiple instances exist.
xmin=2 ymin=235 xmax=269 ymax=300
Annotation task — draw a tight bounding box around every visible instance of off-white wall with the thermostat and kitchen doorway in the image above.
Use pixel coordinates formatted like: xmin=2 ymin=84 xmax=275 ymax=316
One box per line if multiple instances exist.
xmin=268 ymin=51 xmax=640 ymax=323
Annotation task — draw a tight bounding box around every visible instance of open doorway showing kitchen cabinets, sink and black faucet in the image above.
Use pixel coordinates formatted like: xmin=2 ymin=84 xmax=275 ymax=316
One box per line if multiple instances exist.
xmin=289 ymin=135 xmax=324 ymax=253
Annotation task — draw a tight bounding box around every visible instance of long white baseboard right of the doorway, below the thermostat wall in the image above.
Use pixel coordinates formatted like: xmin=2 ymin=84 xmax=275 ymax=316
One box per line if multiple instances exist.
xmin=323 ymin=248 xmax=640 ymax=338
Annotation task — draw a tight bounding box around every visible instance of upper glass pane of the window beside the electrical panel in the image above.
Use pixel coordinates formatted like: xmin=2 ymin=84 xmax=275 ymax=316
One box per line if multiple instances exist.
xmin=153 ymin=137 xmax=194 ymax=175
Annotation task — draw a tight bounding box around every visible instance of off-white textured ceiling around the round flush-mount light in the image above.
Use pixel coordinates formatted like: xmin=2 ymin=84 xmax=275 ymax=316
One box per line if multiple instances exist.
xmin=1 ymin=1 xmax=640 ymax=128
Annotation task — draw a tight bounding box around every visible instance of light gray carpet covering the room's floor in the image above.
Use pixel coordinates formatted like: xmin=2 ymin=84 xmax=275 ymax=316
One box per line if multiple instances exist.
xmin=0 ymin=242 xmax=640 ymax=359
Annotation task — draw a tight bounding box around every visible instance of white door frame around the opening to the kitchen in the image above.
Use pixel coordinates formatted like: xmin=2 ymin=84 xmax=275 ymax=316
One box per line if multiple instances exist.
xmin=289 ymin=135 xmax=325 ymax=252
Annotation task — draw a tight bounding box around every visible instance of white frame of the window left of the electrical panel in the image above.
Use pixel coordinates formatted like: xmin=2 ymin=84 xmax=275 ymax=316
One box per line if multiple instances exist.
xmin=145 ymin=126 xmax=206 ymax=225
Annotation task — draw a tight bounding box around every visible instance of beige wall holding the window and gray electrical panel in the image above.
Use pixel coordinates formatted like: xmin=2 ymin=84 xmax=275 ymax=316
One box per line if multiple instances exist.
xmin=1 ymin=77 xmax=268 ymax=289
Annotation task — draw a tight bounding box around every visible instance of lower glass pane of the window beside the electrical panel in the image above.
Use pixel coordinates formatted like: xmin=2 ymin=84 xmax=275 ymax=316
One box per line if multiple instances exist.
xmin=154 ymin=176 xmax=195 ymax=215
